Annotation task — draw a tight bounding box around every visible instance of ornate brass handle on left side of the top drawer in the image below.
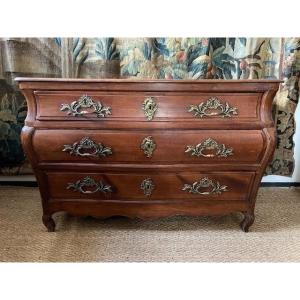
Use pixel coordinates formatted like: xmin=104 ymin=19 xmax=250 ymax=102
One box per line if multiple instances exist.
xmin=60 ymin=95 xmax=111 ymax=118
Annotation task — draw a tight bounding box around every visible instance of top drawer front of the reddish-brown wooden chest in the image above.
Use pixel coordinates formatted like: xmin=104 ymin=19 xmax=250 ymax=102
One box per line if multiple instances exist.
xmin=35 ymin=91 xmax=262 ymax=122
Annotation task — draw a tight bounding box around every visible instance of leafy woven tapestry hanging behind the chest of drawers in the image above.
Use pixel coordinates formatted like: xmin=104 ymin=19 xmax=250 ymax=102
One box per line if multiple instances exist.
xmin=0 ymin=37 xmax=300 ymax=176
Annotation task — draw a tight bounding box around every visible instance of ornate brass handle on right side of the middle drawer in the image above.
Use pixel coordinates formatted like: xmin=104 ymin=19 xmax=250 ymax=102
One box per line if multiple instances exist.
xmin=185 ymin=138 xmax=233 ymax=157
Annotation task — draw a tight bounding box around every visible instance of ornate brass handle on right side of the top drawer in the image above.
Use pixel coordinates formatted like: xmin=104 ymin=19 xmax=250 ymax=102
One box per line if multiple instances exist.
xmin=188 ymin=97 xmax=238 ymax=118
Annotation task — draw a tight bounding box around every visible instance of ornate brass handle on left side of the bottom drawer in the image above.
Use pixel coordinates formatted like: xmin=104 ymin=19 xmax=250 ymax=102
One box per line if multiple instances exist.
xmin=67 ymin=176 xmax=112 ymax=194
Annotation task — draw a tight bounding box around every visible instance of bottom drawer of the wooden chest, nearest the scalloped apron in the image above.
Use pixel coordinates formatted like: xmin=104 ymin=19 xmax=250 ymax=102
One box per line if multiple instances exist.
xmin=46 ymin=172 xmax=255 ymax=201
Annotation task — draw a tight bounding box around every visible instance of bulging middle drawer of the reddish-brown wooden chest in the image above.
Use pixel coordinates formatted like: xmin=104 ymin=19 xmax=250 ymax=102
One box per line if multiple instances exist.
xmin=33 ymin=129 xmax=265 ymax=164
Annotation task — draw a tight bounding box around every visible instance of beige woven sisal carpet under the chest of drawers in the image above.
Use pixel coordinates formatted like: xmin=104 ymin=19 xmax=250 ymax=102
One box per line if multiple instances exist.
xmin=0 ymin=186 xmax=300 ymax=262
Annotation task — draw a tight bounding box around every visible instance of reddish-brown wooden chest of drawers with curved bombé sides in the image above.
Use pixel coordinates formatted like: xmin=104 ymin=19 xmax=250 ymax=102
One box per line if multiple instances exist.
xmin=16 ymin=78 xmax=279 ymax=231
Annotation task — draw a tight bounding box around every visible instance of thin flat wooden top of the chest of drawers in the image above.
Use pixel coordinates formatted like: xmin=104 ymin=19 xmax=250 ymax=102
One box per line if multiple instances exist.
xmin=15 ymin=77 xmax=281 ymax=92
